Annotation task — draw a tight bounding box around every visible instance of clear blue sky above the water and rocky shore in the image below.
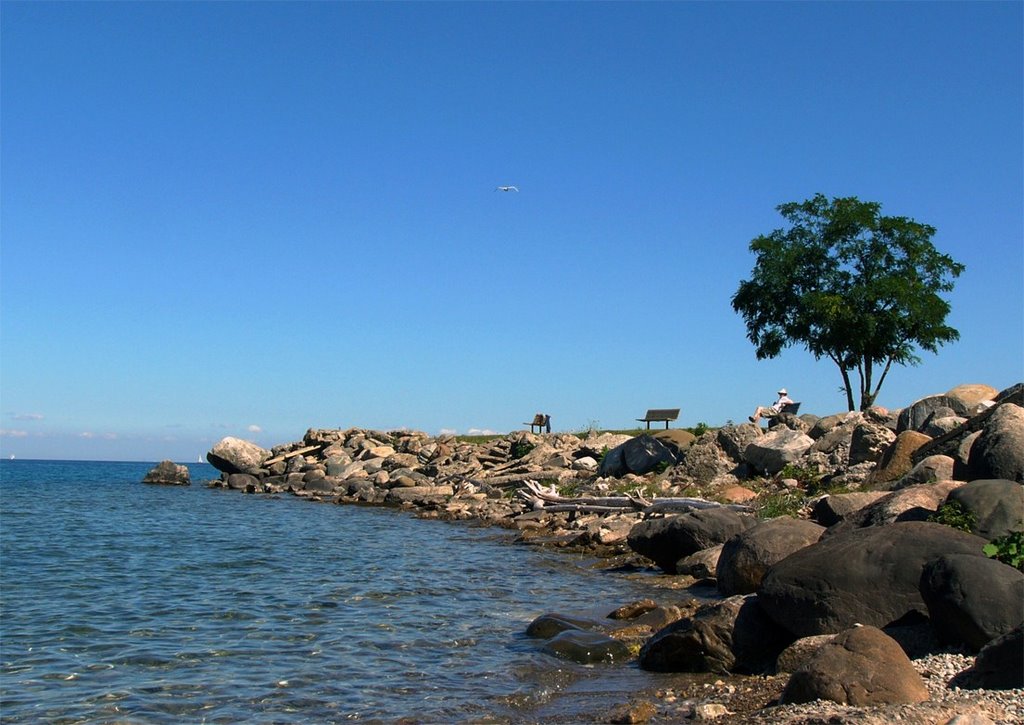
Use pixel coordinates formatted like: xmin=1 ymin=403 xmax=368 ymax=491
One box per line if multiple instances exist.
xmin=0 ymin=1 xmax=1024 ymax=461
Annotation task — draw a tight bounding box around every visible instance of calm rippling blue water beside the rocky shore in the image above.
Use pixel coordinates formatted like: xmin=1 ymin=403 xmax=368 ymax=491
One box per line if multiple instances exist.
xmin=0 ymin=461 xmax=679 ymax=723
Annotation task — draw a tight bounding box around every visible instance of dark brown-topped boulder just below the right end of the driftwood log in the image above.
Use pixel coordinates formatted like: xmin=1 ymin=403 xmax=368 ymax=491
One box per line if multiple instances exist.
xmin=627 ymin=508 xmax=757 ymax=573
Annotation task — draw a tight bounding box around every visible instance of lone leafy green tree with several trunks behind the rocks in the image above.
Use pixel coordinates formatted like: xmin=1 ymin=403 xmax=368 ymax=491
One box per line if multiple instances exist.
xmin=732 ymin=194 xmax=964 ymax=411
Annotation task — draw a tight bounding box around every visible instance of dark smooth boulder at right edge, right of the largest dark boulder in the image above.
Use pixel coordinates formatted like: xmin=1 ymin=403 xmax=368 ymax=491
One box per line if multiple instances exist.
xmin=921 ymin=554 xmax=1024 ymax=651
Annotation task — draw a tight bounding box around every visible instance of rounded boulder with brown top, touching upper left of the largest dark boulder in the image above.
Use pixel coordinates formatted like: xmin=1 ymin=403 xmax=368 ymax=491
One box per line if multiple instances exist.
xmin=715 ymin=516 xmax=825 ymax=596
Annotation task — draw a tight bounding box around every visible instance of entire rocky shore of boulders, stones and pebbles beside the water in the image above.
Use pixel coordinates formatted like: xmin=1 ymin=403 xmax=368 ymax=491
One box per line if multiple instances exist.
xmin=165 ymin=385 xmax=1024 ymax=725
